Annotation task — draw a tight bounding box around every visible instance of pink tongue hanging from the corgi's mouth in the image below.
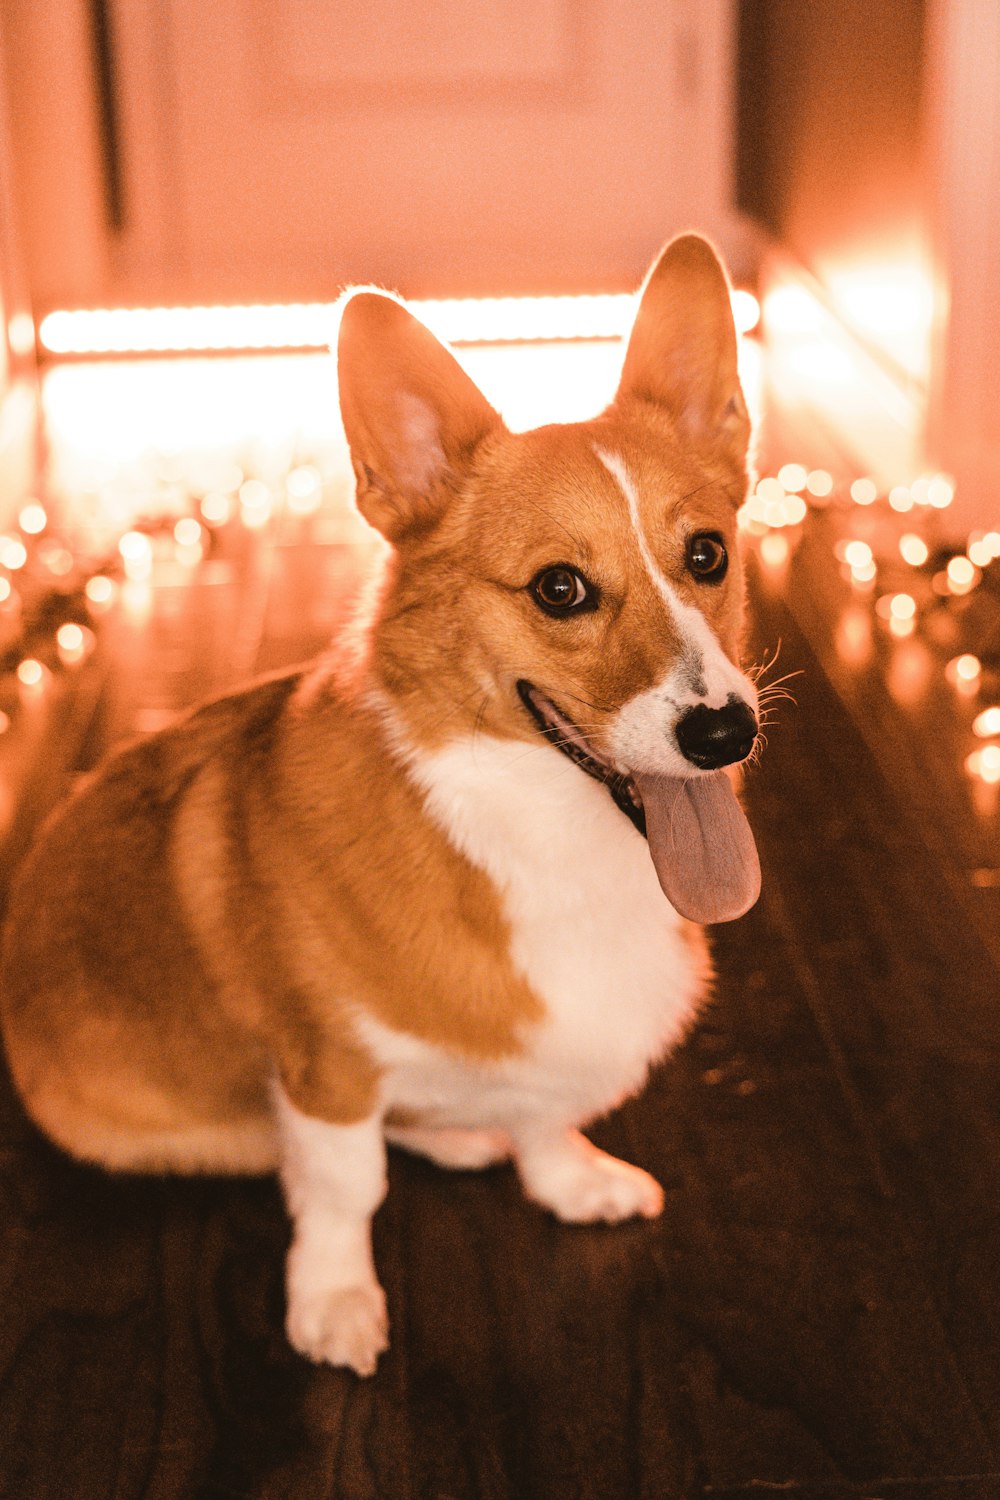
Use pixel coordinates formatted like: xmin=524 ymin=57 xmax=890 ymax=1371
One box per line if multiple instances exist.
xmin=633 ymin=771 xmax=760 ymax=923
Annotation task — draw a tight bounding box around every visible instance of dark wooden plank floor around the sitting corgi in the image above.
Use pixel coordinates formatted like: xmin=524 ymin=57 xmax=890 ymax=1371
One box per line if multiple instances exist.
xmin=0 ymin=384 xmax=1000 ymax=1500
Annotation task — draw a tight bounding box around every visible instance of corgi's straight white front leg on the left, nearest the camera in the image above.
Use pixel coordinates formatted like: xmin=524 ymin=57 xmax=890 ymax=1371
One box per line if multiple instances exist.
xmin=276 ymin=1088 xmax=388 ymax=1376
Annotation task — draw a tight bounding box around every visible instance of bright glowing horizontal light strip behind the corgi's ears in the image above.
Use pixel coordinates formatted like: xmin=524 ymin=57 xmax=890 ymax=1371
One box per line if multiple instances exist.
xmin=39 ymin=291 xmax=760 ymax=354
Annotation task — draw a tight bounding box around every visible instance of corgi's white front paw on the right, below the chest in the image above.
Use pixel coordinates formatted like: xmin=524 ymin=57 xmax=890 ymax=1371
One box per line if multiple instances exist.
xmin=514 ymin=1127 xmax=663 ymax=1224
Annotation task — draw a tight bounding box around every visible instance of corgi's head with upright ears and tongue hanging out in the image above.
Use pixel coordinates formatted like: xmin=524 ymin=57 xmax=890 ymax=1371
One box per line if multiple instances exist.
xmin=339 ymin=236 xmax=760 ymax=921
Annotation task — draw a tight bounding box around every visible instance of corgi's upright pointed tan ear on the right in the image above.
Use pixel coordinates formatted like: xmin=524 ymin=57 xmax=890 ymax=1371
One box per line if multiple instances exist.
xmin=615 ymin=234 xmax=750 ymax=461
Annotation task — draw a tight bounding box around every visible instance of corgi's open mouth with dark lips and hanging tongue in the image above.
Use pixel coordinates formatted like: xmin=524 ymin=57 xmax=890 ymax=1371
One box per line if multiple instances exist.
xmin=517 ymin=678 xmax=760 ymax=923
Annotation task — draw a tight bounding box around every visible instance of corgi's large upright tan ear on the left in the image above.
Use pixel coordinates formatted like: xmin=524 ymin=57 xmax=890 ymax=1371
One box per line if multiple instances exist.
xmin=337 ymin=291 xmax=504 ymax=542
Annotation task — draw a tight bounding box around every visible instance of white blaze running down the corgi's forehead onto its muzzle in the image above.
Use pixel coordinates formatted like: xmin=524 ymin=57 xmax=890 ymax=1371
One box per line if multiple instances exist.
xmin=594 ymin=447 xmax=757 ymax=777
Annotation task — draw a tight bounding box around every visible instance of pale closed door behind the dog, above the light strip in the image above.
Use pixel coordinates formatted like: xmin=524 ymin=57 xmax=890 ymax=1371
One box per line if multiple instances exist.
xmin=109 ymin=0 xmax=732 ymax=302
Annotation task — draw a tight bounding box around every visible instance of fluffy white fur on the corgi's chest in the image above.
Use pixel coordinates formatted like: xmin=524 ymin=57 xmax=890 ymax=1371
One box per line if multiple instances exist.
xmin=360 ymin=737 xmax=703 ymax=1127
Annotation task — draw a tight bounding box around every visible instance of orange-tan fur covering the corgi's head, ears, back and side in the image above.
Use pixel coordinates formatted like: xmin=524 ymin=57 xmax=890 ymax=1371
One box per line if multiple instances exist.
xmin=3 ymin=231 xmax=747 ymax=1170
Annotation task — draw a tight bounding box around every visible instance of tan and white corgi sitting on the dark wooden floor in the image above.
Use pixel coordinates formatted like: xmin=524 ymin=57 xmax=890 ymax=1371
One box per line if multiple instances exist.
xmin=1 ymin=236 xmax=760 ymax=1374
